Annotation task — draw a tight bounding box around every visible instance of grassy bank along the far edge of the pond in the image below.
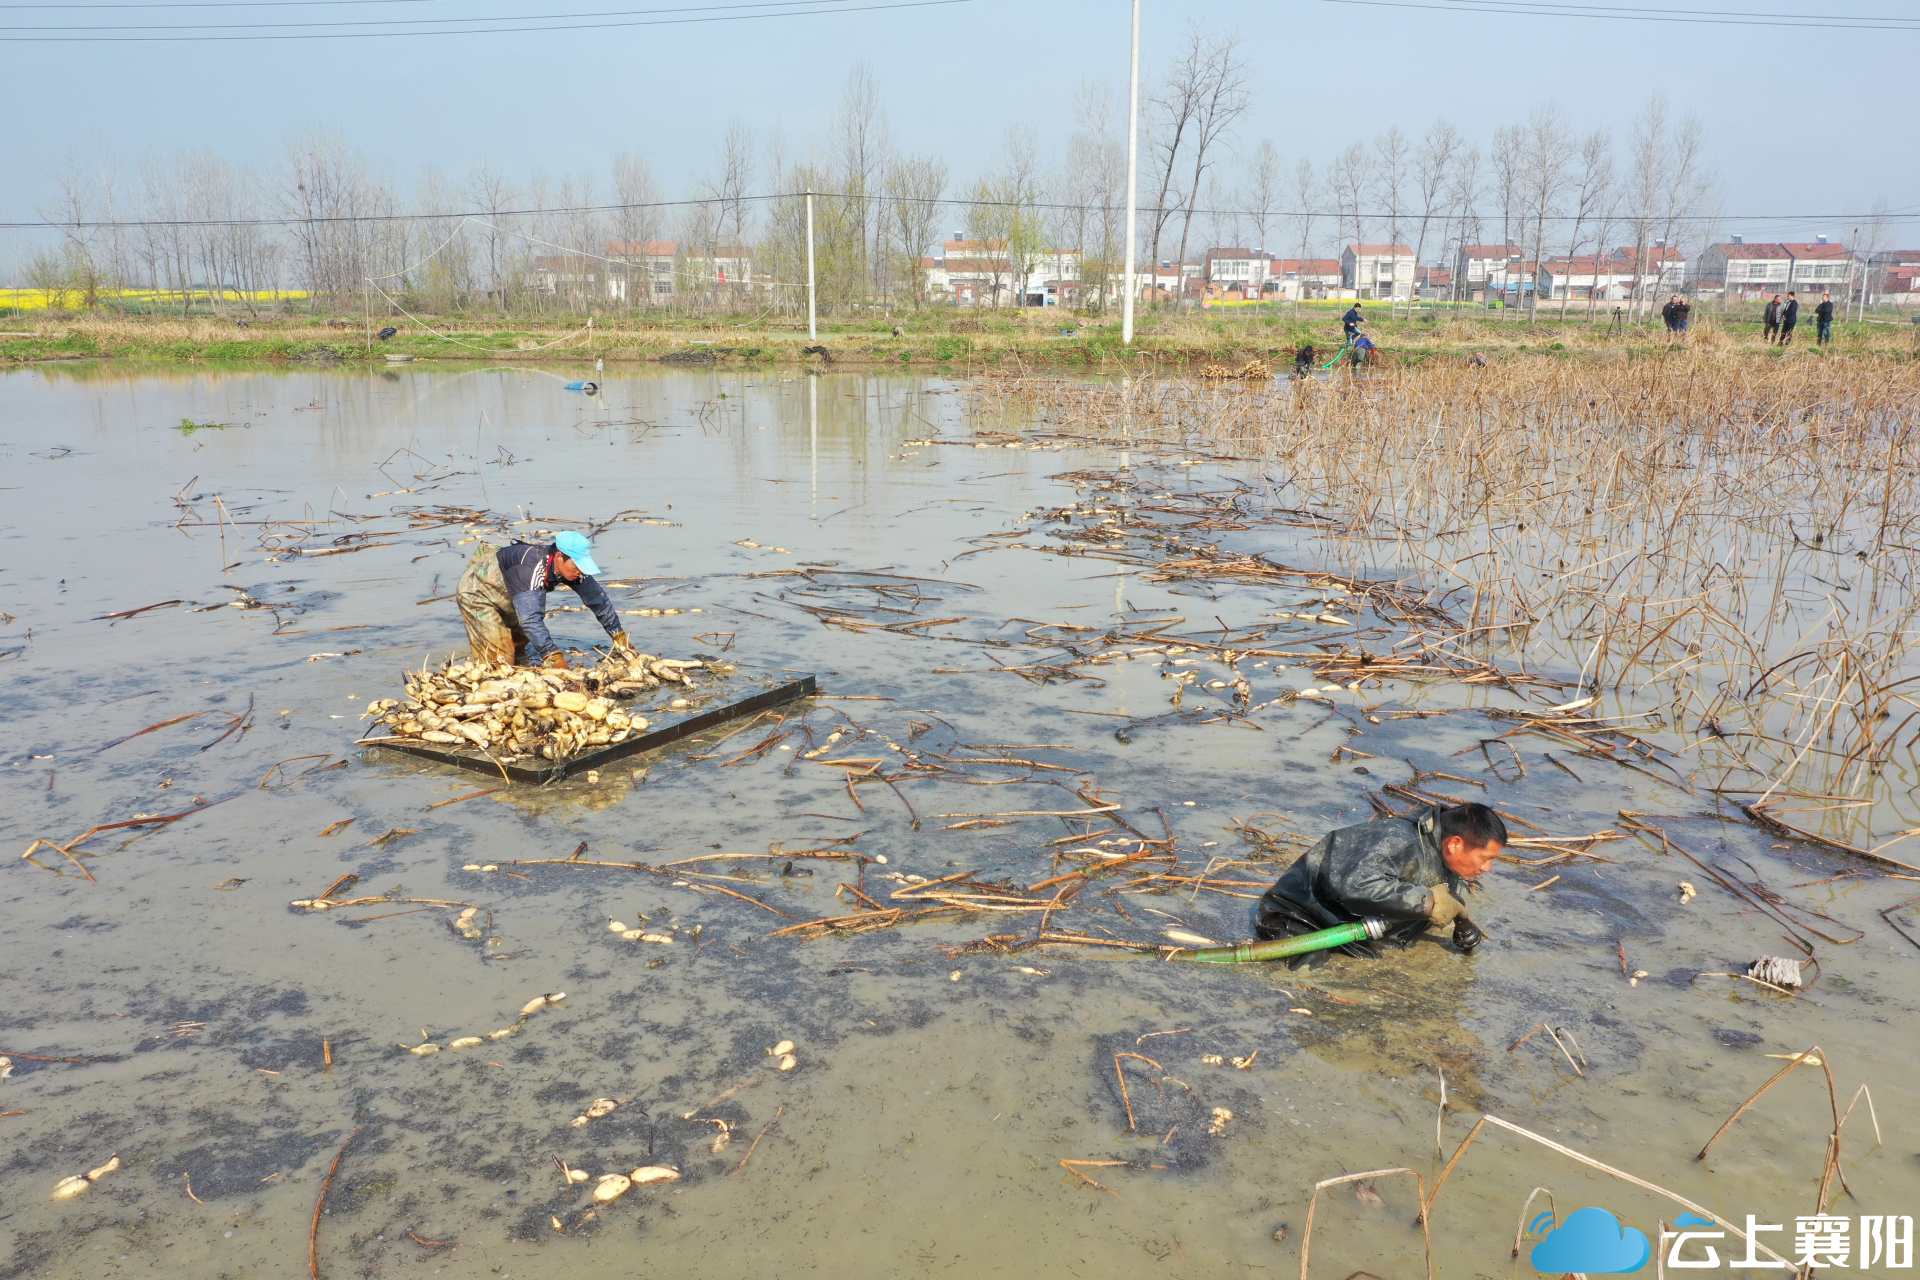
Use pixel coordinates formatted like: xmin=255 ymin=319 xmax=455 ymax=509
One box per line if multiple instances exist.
xmin=0 ymin=303 xmax=1920 ymax=372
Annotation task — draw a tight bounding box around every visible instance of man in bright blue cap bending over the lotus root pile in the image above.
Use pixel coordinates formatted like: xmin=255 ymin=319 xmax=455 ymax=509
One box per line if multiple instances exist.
xmin=453 ymin=532 xmax=630 ymax=666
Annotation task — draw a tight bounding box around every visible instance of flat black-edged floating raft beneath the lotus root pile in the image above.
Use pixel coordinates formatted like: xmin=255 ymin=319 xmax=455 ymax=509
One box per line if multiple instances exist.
xmin=367 ymin=668 xmax=818 ymax=783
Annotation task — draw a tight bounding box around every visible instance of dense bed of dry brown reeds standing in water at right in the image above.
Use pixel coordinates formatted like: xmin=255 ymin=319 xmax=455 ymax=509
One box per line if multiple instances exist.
xmin=973 ymin=351 xmax=1920 ymax=858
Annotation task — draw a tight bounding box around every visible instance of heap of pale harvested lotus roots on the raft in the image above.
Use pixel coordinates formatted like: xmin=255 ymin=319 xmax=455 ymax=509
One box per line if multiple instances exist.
xmin=363 ymin=649 xmax=707 ymax=760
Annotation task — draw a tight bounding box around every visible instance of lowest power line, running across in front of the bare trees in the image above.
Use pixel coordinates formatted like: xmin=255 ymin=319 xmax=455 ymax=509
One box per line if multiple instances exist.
xmin=0 ymin=192 xmax=1920 ymax=234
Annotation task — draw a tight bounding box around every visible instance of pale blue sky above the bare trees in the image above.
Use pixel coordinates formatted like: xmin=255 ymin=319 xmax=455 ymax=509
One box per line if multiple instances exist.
xmin=0 ymin=0 xmax=1920 ymax=261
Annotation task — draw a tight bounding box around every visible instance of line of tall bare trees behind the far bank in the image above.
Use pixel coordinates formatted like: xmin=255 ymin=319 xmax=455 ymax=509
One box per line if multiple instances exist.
xmin=17 ymin=27 xmax=1716 ymax=315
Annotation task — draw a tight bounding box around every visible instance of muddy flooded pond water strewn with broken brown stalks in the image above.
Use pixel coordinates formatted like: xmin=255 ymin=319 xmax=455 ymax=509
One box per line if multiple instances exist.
xmin=0 ymin=365 xmax=1920 ymax=1280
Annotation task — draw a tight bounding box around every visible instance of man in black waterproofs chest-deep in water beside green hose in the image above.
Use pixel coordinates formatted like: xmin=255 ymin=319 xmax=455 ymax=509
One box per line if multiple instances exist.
xmin=1254 ymin=804 xmax=1507 ymax=969
